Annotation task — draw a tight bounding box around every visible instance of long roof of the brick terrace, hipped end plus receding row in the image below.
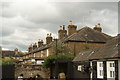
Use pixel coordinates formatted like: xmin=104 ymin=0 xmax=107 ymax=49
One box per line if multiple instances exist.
xmin=25 ymin=27 xmax=112 ymax=55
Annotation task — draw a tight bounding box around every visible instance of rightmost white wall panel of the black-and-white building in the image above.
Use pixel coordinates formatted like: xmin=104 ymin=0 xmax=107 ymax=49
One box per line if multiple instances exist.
xmin=107 ymin=61 xmax=115 ymax=80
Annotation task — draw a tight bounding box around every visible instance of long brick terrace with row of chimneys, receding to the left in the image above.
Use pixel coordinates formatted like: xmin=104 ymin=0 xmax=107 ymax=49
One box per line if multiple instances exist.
xmin=19 ymin=21 xmax=112 ymax=64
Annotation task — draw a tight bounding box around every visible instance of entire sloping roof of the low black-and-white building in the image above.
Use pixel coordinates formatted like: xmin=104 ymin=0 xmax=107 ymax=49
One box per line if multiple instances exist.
xmin=73 ymin=36 xmax=120 ymax=61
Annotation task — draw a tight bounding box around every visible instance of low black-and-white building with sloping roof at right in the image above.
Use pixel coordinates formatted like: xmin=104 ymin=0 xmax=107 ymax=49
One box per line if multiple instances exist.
xmin=73 ymin=35 xmax=120 ymax=80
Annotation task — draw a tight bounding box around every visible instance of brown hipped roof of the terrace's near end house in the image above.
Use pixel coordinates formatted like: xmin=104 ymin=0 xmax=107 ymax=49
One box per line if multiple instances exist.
xmin=65 ymin=27 xmax=112 ymax=42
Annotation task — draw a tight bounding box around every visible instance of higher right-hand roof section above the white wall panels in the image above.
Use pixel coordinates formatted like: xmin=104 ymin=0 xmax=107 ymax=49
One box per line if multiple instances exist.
xmin=91 ymin=36 xmax=120 ymax=59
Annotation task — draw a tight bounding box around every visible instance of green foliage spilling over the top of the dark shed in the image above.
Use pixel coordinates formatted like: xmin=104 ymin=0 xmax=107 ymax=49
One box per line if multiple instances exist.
xmin=43 ymin=54 xmax=74 ymax=68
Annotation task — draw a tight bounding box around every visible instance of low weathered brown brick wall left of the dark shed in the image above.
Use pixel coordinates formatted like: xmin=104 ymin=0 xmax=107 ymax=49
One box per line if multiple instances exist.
xmin=15 ymin=65 xmax=49 ymax=78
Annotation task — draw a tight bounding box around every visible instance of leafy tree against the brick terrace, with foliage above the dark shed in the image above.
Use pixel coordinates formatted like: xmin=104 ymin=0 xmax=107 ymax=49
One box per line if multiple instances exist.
xmin=43 ymin=41 xmax=74 ymax=68
